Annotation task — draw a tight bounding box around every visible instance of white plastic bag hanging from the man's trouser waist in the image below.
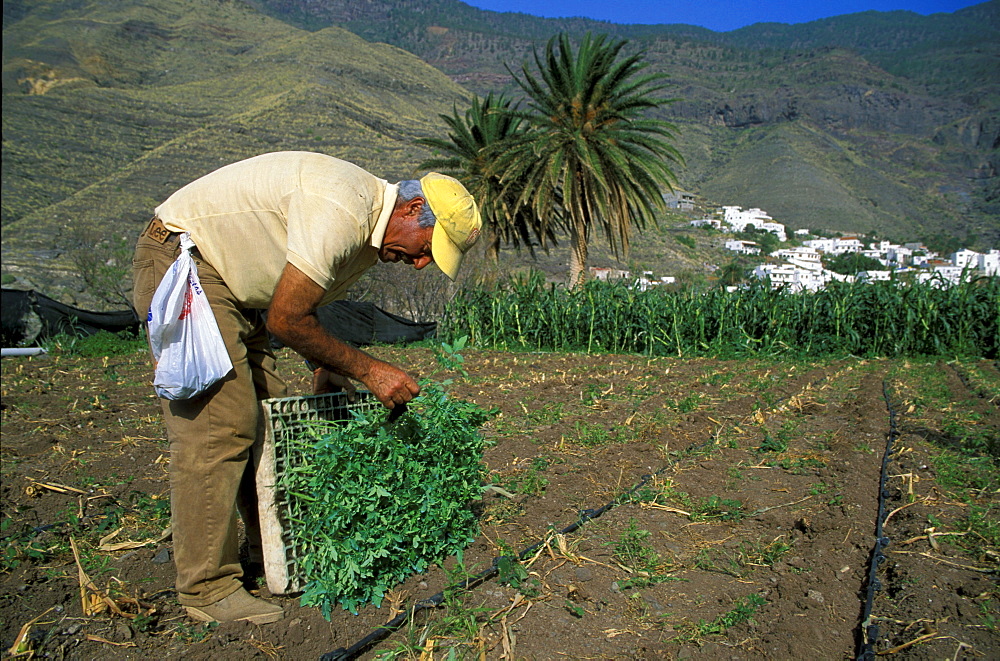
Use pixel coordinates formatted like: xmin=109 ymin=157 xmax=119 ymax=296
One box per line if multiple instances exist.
xmin=146 ymin=232 xmax=233 ymax=399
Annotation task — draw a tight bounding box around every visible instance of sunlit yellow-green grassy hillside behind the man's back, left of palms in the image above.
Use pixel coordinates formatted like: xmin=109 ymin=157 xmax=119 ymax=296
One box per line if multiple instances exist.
xmin=3 ymin=0 xmax=467 ymax=302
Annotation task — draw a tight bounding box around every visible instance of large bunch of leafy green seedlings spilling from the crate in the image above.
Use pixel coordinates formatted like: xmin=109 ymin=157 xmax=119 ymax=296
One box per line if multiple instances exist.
xmin=279 ymin=382 xmax=494 ymax=618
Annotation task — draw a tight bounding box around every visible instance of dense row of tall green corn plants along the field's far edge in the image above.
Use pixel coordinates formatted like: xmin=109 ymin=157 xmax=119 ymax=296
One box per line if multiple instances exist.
xmin=441 ymin=273 xmax=1000 ymax=358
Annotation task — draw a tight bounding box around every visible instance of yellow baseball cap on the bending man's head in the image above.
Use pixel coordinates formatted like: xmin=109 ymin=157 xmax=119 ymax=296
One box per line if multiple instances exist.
xmin=420 ymin=172 xmax=483 ymax=280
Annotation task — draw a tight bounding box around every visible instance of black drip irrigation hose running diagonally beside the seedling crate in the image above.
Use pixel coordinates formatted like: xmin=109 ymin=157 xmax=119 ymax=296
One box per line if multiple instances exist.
xmin=320 ymin=464 xmax=671 ymax=661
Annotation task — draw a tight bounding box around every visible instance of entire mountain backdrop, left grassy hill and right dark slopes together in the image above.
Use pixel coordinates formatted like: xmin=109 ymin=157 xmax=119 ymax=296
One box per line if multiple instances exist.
xmin=0 ymin=0 xmax=1000 ymax=302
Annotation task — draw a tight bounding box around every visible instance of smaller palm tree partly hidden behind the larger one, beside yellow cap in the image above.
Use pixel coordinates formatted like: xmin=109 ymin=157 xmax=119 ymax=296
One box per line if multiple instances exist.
xmin=417 ymin=93 xmax=556 ymax=265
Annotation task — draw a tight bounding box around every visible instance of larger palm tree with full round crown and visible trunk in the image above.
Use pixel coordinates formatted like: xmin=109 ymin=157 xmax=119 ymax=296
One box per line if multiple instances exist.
xmin=494 ymin=33 xmax=683 ymax=287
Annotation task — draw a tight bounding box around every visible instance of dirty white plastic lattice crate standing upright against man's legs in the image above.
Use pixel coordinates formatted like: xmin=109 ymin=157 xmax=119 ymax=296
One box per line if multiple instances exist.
xmin=253 ymin=390 xmax=381 ymax=594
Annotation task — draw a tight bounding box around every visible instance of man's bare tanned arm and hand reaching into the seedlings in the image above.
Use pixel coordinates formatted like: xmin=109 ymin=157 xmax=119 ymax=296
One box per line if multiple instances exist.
xmin=267 ymin=264 xmax=420 ymax=409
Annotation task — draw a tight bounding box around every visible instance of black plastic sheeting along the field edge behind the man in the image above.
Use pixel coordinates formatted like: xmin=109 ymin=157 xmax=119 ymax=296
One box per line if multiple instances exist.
xmin=0 ymin=288 xmax=437 ymax=348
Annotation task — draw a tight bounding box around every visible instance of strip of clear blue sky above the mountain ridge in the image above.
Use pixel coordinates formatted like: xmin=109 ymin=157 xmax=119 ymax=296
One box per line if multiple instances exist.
xmin=463 ymin=0 xmax=984 ymax=32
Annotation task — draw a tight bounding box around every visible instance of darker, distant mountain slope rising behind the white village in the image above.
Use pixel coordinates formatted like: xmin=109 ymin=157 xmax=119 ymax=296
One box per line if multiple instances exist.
xmin=244 ymin=0 xmax=1000 ymax=245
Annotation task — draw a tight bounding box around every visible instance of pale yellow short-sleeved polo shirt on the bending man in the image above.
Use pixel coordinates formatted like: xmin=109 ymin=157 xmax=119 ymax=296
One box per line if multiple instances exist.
xmin=156 ymin=152 xmax=398 ymax=309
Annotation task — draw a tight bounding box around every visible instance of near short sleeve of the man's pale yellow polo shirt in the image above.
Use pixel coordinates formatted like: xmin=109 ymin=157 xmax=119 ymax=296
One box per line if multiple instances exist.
xmin=286 ymin=190 xmax=366 ymax=291
